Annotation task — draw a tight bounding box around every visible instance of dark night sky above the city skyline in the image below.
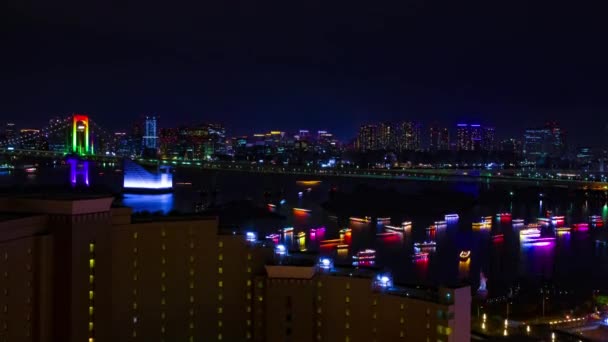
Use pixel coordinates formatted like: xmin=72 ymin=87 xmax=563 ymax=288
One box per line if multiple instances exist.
xmin=0 ymin=0 xmax=608 ymax=146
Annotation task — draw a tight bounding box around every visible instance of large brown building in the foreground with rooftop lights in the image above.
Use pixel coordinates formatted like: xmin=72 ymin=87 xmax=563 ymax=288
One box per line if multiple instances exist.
xmin=0 ymin=194 xmax=471 ymax=342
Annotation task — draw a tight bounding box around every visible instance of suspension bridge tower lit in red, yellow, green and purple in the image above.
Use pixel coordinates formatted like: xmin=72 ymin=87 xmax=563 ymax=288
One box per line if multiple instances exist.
xmin=67 ymin=114 xmax=94 ymax=187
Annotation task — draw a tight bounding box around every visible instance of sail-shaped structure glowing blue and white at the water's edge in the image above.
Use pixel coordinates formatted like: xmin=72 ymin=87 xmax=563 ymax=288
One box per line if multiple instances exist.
xmin=123 ymin=161 xmax=173 ymax=193
